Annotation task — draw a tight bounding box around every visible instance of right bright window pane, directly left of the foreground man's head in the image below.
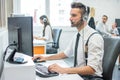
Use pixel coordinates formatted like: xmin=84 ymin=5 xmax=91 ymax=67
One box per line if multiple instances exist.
xmin=50 ymin=0 xmax=73 ymax=26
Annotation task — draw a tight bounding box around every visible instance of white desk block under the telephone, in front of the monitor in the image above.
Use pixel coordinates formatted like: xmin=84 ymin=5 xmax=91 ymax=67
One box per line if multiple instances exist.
xmin=3 ymin=54 xmax=36 ymax=80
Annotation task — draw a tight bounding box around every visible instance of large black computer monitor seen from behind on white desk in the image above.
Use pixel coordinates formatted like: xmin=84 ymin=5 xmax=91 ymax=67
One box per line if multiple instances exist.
xmin=8 ymin=17 xmax=33 ymax=56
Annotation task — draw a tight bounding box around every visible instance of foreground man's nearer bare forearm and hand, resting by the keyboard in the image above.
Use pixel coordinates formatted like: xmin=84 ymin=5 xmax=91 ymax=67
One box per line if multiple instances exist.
xmin=48 ymin=64 xmax=95 ymax=75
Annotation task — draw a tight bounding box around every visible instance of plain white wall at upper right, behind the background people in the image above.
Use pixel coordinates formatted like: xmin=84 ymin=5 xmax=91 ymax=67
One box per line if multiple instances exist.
xmin=74 ymin=0 xmax=120 ymax=25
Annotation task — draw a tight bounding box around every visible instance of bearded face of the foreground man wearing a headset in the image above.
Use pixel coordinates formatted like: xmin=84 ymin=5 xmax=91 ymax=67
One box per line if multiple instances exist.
xmin=70 ymin=8 xmax=81 ymax=27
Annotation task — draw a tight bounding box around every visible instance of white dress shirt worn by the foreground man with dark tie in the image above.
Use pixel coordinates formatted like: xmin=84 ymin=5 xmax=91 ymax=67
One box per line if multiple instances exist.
xmin=64 ymin=25 xmax=104 ymax=76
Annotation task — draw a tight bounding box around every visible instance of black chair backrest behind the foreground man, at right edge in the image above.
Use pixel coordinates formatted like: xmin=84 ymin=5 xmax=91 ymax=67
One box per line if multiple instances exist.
xmin=103 ymin=38 xmax=120 ymax=80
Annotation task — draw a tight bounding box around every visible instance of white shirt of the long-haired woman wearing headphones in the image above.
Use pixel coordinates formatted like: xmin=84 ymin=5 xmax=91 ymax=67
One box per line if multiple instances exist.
xmin=43 ymin=25 xmax=53 ymax=42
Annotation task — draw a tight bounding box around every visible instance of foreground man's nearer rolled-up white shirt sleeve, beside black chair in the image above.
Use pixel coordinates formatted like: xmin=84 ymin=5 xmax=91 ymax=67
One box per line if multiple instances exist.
xmin=87 ymin=34 xmax=104 ymax=72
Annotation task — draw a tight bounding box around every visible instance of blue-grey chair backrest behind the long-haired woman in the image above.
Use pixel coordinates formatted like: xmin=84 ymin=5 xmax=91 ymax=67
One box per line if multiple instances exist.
xmin=52 ymin=29 xmax=62 ymax=49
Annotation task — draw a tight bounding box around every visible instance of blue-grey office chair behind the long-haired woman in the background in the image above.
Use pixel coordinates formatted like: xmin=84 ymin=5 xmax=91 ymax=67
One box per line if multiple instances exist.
xmin=46 ymin=29 xmax=62 ymax=54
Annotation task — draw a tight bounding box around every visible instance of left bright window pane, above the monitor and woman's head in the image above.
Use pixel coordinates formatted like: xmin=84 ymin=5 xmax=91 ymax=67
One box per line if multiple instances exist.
xmin=21 ymin=0 xmax=45 ymax=25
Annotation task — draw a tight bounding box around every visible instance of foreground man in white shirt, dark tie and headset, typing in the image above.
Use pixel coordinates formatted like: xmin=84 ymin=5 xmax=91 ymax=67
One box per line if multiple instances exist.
xmin=33 ymin=2 xmax=104 ymax=77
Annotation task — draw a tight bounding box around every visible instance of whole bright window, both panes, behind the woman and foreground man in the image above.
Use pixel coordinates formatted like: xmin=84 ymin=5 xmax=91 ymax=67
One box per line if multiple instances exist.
xmin=21 ymin=0 xmax=73 ymax=26
